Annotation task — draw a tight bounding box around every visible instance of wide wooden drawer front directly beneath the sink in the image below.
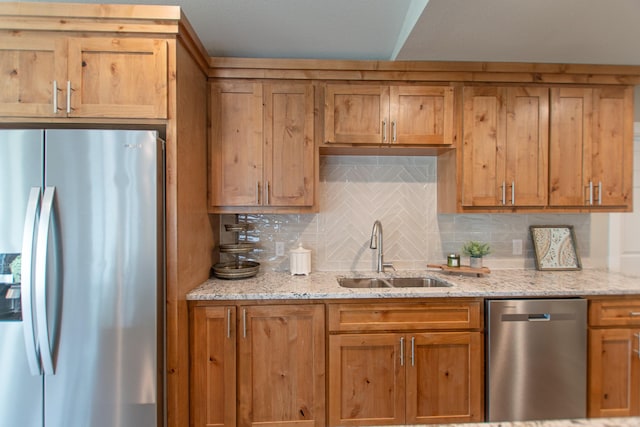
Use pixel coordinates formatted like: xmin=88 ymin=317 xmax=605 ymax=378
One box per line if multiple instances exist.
xmin=328 ymin=300 xmax=482 ymax=331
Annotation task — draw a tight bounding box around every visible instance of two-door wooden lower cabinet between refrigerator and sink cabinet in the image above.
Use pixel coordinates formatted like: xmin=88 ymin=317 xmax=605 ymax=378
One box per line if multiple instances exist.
xmin=191 ymin=304 xmax=325 ymax=427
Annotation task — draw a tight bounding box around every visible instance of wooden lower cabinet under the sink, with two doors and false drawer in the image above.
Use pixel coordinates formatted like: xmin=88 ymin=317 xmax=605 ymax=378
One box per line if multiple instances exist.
xmin=328 ymin=301 xmax=484 ymax=426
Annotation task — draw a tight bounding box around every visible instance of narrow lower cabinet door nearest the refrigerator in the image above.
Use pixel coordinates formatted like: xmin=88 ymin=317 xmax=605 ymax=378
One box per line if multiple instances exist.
xmin=190 ymin=307 xmax=236 ymax=427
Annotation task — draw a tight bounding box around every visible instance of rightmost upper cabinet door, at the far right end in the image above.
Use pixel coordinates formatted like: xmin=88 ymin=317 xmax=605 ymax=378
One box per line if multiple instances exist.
xmin=589 ymin=87 xmax=633 ymax=209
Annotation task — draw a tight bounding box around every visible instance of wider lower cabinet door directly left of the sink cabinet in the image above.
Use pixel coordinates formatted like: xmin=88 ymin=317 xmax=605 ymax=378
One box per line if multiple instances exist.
xmin=238 ymin=305 xmax=325 ymax=427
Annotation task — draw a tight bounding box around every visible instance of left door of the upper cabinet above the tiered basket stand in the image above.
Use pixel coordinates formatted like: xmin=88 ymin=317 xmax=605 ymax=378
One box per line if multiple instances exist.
xmin=209 ymin=82 xmax=263 ymax=206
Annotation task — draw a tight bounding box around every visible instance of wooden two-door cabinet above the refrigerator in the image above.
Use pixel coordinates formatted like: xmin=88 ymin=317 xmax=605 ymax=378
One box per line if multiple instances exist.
xmin=0 ymin=34 xmax=168 ymax=119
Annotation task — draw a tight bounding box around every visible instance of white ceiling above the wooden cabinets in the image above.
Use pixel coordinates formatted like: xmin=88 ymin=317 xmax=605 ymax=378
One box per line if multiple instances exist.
xmin=8 ymin=0 xmax=640 ymax=65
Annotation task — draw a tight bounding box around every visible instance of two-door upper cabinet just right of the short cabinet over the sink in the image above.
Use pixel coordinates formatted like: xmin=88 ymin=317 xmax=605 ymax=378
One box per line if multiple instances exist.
xmin=462 ymin=87 xmax=549 ymax=207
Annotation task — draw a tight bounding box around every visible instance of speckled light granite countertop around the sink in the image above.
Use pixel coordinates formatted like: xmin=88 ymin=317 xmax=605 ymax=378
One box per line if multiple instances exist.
xmin=187 ymin=269 xmax=640 ymax=300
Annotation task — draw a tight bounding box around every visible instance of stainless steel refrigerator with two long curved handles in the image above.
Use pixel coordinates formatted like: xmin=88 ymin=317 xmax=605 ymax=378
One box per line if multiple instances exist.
xmin=0 ymin=129 xmax=164 ymax=427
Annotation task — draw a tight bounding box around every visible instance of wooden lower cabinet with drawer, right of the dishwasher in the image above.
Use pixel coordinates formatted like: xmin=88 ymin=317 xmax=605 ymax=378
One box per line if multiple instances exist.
xmin=587 ymin=297 xmax=640 ymax=417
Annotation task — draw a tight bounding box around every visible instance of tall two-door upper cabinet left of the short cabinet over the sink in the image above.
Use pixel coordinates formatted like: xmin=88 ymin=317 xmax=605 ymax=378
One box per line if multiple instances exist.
xmin=210 ymin=81 xmax=317 ymax=212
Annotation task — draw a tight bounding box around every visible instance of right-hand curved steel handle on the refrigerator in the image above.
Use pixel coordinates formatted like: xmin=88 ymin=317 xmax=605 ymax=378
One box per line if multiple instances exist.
xmin=35 ymin=187 xmax=55 ymax=375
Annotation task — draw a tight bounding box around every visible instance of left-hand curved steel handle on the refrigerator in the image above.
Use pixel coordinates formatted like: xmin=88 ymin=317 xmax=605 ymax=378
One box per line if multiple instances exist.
xmin=20 ymin=187 xmax=42 ymax=375
